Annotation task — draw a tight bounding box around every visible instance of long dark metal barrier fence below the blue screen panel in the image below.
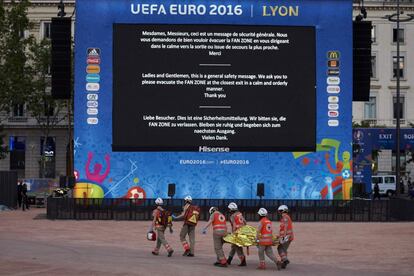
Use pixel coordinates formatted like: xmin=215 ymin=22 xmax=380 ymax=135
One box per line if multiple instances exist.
xmin=47 ymin=197 xmax=414 ymax=222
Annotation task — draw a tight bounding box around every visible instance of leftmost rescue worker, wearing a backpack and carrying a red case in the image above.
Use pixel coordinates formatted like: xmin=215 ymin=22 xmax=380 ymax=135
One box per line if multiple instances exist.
xmin=150 ymin=198 xmax=174 ymax=257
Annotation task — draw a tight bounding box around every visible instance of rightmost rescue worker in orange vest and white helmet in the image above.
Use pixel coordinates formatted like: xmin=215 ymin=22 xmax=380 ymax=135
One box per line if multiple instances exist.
xmin=277 ymin=205 xmax=293 ymax=269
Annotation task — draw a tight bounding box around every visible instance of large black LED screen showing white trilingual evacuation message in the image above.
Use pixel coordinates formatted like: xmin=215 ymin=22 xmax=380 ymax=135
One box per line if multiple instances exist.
xmin=112 ymin=24 xmax=316 ymax=151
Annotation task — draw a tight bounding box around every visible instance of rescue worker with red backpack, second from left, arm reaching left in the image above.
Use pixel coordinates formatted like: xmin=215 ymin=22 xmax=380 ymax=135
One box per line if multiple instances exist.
xmin=173 ymin=196 xmax=200 ymax=257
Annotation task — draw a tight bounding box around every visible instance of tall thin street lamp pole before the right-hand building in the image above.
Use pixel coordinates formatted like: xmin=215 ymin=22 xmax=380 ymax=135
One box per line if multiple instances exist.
xmin=385 ymin=0 xmax=414 ymax=195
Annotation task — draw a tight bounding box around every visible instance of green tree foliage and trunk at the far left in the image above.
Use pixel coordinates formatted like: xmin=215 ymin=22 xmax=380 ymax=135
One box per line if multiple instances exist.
xmin=0 ymin=0 xmax=66 ymax=175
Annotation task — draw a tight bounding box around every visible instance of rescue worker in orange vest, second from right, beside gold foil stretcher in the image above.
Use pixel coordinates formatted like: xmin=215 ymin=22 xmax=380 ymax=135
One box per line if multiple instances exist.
xmin=256 ymin=208 xmax=281 ymax=270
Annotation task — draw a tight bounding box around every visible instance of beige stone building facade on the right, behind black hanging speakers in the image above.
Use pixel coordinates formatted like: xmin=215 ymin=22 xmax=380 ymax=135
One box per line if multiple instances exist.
xmin=352 ymin=0 xmax=414 ymax=127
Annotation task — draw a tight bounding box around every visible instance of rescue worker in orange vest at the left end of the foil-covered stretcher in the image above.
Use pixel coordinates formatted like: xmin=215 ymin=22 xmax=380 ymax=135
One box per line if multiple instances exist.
xmin=203 ymin=207 xmax=227 ymax=267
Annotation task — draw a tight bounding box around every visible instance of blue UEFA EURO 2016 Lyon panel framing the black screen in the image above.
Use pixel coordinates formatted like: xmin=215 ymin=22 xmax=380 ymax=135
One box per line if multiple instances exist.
xmin=75 ymin=0 xmax=352 ymax=199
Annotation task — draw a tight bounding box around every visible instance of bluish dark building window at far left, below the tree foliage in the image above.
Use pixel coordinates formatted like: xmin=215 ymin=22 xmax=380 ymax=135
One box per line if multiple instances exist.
xmin=9 ymin=136 xmax=26 ymax=178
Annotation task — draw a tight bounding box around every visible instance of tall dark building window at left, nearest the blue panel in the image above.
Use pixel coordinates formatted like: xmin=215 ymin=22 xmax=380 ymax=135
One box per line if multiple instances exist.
xmin=39 ymin=137 xmax=56 ymax=178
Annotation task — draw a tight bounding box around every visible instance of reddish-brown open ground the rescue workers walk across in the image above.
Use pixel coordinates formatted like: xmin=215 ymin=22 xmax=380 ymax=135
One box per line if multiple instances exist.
xmin=0 ymin=209 xmax=414 ymax=276
